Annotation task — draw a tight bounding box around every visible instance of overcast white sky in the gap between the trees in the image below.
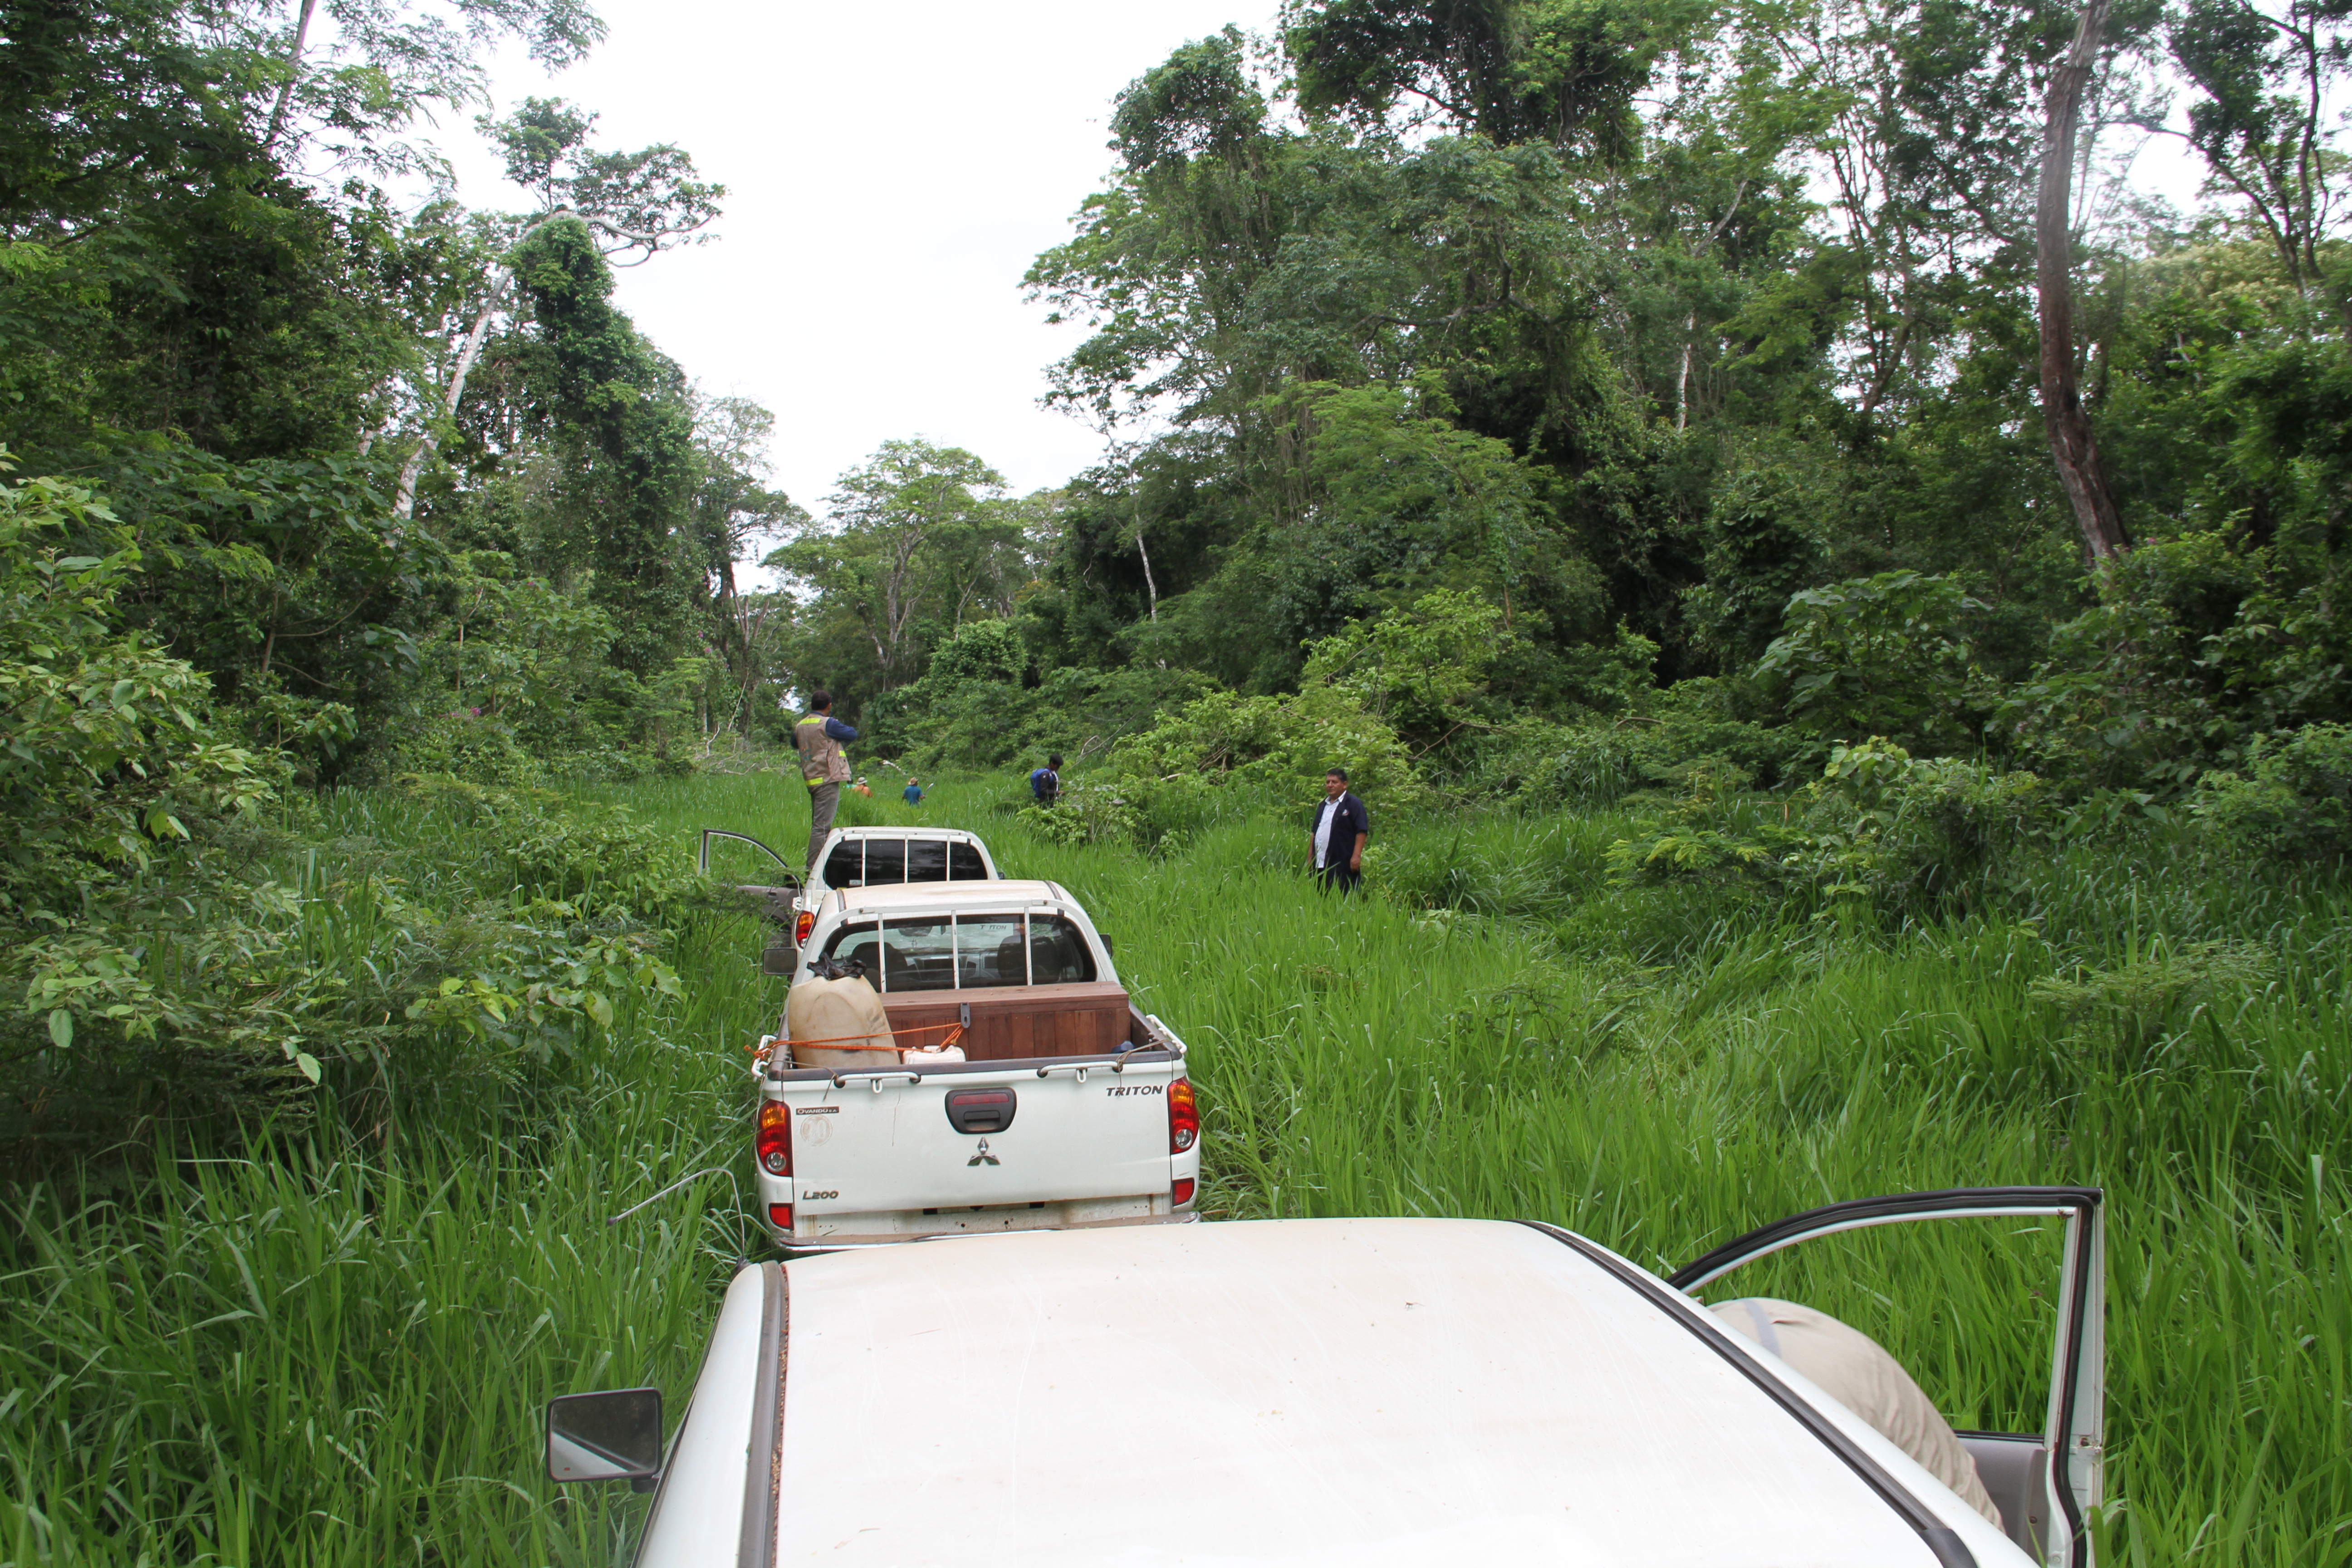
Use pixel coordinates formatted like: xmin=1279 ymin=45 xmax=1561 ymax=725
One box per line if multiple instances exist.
xmin=442 ymin=0 xmax=1277 ymax=526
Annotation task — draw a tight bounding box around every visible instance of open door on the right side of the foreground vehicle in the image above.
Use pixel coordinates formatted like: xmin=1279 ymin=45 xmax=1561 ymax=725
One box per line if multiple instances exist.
xmin=1667 ymin=1187 xmax=2107 ymax=1568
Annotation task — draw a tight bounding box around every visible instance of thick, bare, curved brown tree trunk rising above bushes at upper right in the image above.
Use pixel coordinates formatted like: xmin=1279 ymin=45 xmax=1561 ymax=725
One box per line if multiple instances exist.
xmin=2034 ymin=0 xmax=2131 ymax=567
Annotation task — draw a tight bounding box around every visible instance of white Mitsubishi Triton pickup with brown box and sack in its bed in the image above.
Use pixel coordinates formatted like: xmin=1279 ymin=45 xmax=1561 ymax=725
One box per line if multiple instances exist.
xmin=753 ymin=879 xmax=1200 ymax=1253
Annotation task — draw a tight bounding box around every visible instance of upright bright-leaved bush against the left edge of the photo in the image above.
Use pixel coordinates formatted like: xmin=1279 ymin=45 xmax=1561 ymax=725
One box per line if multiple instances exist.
xmin=0 ymin=465 xmax=296 ymax=1105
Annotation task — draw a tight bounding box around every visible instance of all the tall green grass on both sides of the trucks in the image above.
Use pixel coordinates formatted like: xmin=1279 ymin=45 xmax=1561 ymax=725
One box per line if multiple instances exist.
xmin=0 ymin=776 xmax=2352 ymax=1566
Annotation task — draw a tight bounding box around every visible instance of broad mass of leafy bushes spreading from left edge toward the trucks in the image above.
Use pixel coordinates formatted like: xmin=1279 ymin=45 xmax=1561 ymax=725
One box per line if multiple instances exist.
xmin=0 ymin=465 xmax=703 ymax=1150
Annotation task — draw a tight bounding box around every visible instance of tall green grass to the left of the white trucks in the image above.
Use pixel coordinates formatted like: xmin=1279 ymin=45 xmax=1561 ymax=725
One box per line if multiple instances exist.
xmin=0 ymin=794 xmax=781 ymax=1566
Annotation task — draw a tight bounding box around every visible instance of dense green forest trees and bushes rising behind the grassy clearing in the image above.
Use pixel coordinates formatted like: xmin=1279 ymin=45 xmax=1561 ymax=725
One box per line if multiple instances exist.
xmin=0 ymin=0 xmax=2352 ymax=1133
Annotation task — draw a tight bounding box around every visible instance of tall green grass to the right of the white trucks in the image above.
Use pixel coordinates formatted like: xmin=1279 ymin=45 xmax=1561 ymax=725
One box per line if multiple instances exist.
xmin=637 ymin=780 xmax=2352 ymax=1563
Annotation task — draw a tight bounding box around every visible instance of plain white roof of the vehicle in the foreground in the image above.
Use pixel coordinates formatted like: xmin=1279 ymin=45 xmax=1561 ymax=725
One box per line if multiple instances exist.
xmin=642 ymin=1220 xmax=2032 ymax=1568
